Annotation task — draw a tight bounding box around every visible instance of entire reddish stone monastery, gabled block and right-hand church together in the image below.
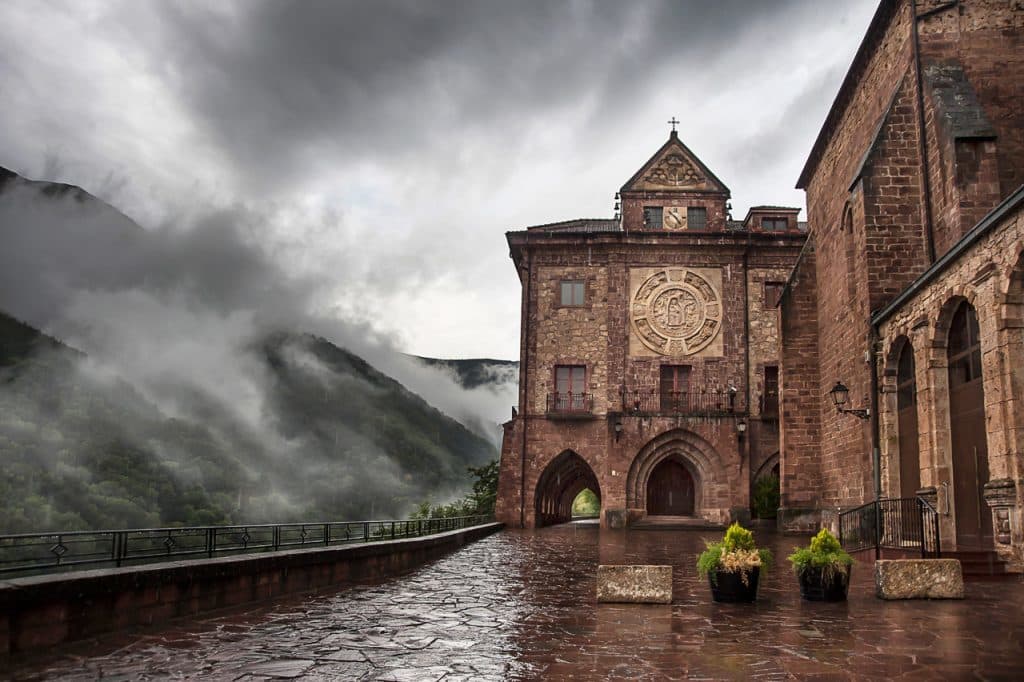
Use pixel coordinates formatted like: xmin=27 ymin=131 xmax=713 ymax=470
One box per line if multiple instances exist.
xmin=497 ymin=0 xmax=1024 ymax=568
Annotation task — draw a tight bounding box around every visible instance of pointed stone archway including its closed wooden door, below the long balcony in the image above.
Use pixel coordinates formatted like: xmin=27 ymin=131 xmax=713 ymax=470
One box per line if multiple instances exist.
xmin=626 ymin=429 xmax=729 ymax=522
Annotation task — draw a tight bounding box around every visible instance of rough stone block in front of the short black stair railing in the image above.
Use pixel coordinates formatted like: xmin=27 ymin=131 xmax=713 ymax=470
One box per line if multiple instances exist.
xmin=874 ymin=559 xmax=964 ymax=599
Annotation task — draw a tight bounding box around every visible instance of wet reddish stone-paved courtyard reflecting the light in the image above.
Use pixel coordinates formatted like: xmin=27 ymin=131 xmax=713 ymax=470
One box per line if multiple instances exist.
xmin=8 ymin=524 xmax=1024 ymax=682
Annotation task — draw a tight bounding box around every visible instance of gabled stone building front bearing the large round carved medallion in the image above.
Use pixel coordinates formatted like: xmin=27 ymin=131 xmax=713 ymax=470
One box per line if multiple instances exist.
xmin=497 ymin=132 xmax=805 ymax=527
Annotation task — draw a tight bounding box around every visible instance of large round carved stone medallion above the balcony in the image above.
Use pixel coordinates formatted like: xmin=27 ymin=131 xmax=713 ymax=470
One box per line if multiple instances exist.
xmin=630 ymin=267 xmax=722 ymax=355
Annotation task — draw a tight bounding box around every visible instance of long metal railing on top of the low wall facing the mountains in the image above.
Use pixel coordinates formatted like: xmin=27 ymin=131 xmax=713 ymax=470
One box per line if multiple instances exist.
xmin=0 ymin=515 xmax=494 ymax=577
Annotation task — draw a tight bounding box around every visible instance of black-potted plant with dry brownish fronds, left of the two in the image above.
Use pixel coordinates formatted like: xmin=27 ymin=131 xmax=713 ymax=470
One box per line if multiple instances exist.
xmin=697 ymin=523 xmax=771 ymax=601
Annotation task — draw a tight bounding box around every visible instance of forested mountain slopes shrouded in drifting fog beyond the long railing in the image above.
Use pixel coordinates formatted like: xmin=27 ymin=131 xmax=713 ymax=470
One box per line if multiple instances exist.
xmin=0 ymin=170 xmax=515 ymax=529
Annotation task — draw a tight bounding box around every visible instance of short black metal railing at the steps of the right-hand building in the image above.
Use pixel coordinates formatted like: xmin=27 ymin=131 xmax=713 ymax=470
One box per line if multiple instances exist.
xmin=839 ymin=498 xmax=942 ymax=558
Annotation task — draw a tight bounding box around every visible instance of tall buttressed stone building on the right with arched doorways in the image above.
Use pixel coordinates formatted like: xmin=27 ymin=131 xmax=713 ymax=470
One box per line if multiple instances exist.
xmin=780 ymin=0 xmax=1024 ymax=566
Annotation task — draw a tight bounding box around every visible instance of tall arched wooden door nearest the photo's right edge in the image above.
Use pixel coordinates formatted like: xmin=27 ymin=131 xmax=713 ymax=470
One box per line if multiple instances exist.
xmin=946 ymin=301 xmax=992 ymax=547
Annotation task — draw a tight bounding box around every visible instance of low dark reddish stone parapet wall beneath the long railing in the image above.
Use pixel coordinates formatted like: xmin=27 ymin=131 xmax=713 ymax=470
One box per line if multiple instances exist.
xmin=0 ymin=523 xmax=503 ymax=659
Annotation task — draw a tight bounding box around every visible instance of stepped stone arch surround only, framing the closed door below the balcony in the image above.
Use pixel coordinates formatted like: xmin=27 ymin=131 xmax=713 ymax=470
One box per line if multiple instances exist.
xmin=626 ymin=429 xmax=728 ymax=520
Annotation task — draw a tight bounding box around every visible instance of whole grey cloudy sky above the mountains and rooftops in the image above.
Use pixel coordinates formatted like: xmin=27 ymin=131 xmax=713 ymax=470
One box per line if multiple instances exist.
xmin=0 ymin=0 xmax=876 ymax=358
